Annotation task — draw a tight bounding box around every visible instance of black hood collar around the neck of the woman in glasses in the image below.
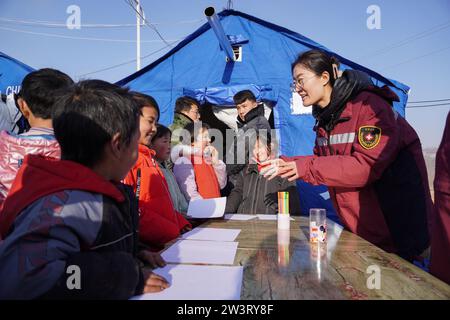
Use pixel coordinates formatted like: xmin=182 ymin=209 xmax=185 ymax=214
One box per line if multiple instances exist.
xmin=313 ymin=70 xmax=373 ymax=132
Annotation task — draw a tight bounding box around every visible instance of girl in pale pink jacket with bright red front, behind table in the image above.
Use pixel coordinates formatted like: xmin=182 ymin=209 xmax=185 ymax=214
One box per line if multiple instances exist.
xmin=173 ymin=122 xmax=227 ymax=200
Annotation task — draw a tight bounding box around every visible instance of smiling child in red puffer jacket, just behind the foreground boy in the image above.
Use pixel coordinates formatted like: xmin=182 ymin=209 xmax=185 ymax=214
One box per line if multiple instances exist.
xmin=124 ymin=92 xmax=191 ymax=250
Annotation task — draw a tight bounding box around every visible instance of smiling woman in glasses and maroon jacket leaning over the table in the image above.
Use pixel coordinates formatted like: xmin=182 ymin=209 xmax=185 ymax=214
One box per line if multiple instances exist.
xmin=262 ymin=50 xmax=433 ymax=261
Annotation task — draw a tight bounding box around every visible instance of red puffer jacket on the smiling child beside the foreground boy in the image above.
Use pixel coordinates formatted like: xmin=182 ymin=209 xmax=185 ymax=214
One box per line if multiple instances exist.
xmin=124 ymin=145 xmax=190 ymax=249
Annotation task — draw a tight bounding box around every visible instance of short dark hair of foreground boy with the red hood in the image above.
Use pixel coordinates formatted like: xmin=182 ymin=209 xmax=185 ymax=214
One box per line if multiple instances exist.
xmin=52 ymin=80 xmax=139 ymax=167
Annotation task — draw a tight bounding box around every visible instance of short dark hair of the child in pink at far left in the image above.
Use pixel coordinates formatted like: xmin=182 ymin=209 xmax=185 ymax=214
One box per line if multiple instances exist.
xmin=19 ymin=68 xmax=74 ymax=119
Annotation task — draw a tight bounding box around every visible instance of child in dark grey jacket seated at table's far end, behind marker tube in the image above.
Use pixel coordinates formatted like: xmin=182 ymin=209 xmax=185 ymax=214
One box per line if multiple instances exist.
xmin=225 ymin=134 xmax=300 ymax=215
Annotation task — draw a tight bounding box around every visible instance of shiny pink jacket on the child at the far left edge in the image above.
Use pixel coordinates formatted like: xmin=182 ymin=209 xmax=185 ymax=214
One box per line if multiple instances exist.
xmin=0 ymin=129 xmax=61 ymax=206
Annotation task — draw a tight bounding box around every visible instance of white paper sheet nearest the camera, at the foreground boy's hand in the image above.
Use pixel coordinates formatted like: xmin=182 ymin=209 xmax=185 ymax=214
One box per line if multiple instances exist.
xmin=132 ymin=264 xmax=243 ymax=300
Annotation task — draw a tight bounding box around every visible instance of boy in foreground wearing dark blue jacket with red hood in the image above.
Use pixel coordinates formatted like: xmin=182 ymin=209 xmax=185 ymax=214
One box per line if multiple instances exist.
xmin=0 ymin=80 xmax=168 ymax=299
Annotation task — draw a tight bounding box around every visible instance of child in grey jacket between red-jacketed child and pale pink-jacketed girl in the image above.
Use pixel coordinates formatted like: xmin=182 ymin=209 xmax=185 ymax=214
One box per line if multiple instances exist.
xmin=150 ymin=124 xmax=189 ymax=213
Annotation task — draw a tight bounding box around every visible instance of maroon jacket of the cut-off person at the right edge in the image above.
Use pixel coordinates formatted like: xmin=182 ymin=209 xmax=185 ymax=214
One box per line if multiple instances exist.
xmin=430 ymin=112 xmax=450 ymax=284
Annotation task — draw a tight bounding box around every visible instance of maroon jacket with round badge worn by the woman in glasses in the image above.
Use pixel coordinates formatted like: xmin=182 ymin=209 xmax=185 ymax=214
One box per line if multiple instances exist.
xmin=285 ymin=86 xmax=433 ymax=259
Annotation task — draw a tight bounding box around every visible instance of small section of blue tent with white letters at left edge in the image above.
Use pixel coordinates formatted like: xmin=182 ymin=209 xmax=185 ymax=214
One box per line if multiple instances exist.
xmin=0 ymin=52 xmax=34 ymax=95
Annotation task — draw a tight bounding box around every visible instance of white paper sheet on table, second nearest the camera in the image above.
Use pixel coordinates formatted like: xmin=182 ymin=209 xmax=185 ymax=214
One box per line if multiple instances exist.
xmin=161 ymin=240 xmax=238 ymax=264
